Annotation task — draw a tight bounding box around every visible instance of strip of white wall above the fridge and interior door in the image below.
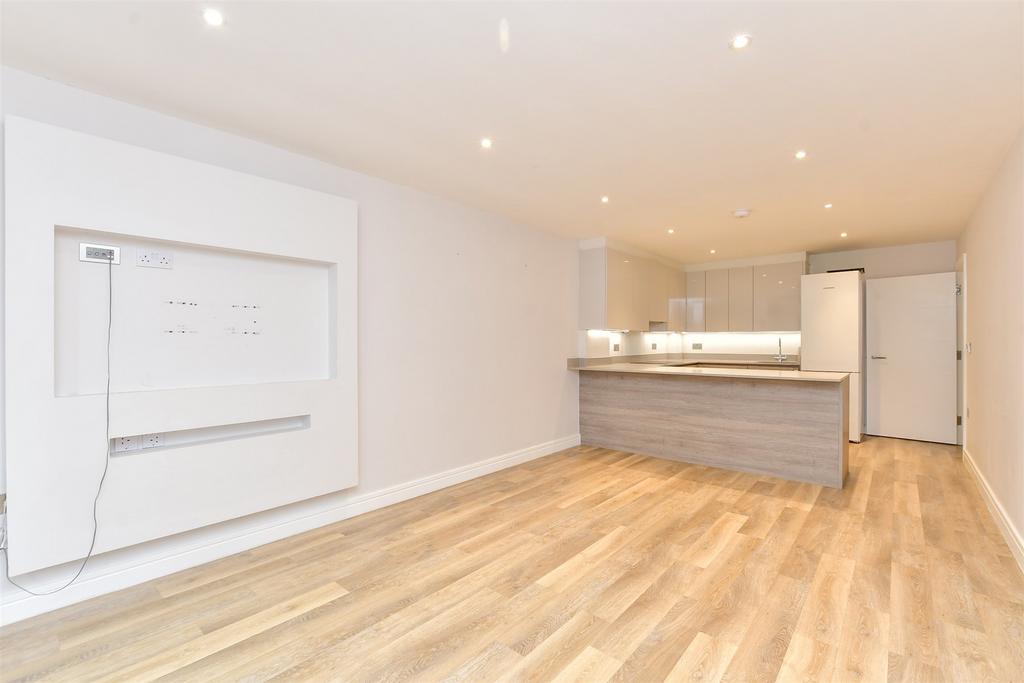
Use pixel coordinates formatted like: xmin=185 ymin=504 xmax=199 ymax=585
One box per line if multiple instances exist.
xmin=807 ymin=240 xmax=956 ymax=278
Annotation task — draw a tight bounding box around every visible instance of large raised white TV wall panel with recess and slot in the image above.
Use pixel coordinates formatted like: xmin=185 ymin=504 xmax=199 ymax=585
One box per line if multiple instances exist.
xmin=4 ymin=117 xmax=358 ymax=575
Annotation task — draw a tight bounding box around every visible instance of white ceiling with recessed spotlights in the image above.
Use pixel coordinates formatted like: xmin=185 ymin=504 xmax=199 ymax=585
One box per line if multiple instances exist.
xmin=2 ymin=1 xmax=1024 ymax=262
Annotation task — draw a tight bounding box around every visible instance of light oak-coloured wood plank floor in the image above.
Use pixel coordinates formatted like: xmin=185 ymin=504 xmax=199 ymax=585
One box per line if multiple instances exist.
xmin=0 ymin=438 xmax=1024 ymax=683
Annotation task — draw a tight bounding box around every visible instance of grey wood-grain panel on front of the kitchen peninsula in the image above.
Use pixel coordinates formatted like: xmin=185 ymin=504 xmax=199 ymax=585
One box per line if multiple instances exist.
xmin=580 ymin=372 xmax=849 ymax=488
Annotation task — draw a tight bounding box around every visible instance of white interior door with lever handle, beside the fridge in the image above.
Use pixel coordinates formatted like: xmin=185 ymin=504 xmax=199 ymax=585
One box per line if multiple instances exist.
xmin=865 ymin=272 xmax=956 ymax=443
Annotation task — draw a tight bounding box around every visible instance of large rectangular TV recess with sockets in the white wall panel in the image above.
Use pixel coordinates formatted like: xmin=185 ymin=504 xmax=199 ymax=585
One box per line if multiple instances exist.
xmin=53 ymin=228 xmax=334 ymax=396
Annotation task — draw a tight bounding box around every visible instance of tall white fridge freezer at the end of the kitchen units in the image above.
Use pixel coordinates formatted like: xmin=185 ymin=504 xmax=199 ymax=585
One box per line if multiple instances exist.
xmin=800 ymin=270 xmax=864 ymax=441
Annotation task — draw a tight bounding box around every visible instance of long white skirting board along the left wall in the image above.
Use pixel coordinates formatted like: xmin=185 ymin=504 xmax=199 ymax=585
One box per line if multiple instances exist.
xmin=0 ymin=434 xmax=580 ymax=626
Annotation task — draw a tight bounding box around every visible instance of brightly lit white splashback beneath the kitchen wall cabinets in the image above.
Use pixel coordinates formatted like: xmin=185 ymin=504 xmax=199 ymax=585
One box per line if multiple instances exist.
xmin=580 ymin=330 xmax=800 ymax=358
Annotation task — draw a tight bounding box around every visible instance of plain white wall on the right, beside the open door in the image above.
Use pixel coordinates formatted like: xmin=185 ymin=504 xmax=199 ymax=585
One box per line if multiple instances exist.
xmin=958 ymin=127 xmax=1024 ymax=566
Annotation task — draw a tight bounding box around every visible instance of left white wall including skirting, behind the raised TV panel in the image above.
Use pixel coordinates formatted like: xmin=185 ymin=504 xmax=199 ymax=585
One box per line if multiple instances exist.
xmin=0 ymin=69 xmax=579 ymax=620
